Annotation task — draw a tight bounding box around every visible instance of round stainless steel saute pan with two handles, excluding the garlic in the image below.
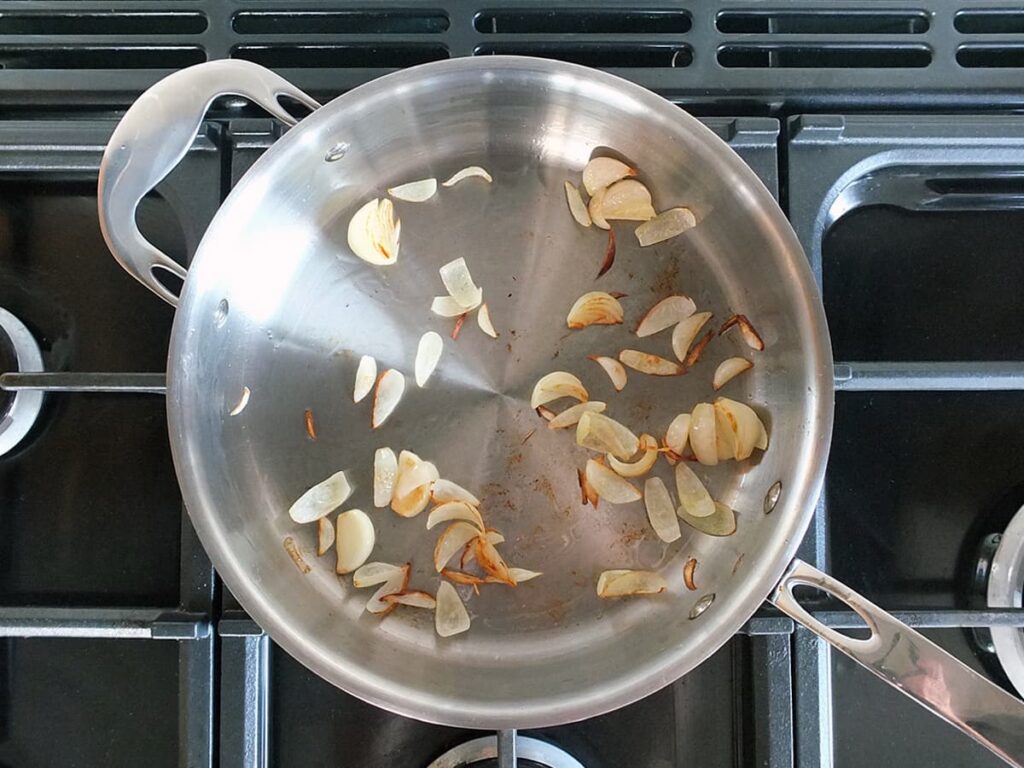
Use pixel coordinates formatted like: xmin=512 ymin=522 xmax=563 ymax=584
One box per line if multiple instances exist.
xmin=99 ymin=56 xmax=1024 ymax=764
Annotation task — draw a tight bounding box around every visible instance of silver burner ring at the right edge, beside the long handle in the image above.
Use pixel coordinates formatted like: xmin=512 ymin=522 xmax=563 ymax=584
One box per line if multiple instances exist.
xmin=988 ymin=507 xmax=1024 ymax=695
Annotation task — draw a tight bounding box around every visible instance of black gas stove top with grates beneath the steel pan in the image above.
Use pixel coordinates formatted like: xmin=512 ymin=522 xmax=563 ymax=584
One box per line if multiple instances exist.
xmin=0 ymin=0 xmax=1024 ymax=768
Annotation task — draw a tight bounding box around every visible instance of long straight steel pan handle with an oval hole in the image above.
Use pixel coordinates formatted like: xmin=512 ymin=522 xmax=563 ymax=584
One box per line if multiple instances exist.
xmin=768 ymin=560 xmax=1024 ymax=766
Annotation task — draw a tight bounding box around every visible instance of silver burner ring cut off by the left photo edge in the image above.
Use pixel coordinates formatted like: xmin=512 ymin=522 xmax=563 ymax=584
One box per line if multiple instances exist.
xmin=0 ymin=308 xmax=43 ymax=456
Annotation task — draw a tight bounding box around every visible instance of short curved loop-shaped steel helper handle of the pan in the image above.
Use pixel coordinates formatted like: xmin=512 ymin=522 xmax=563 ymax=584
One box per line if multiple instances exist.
xmin=97 ymin=59 xmax=319 ymax=306
